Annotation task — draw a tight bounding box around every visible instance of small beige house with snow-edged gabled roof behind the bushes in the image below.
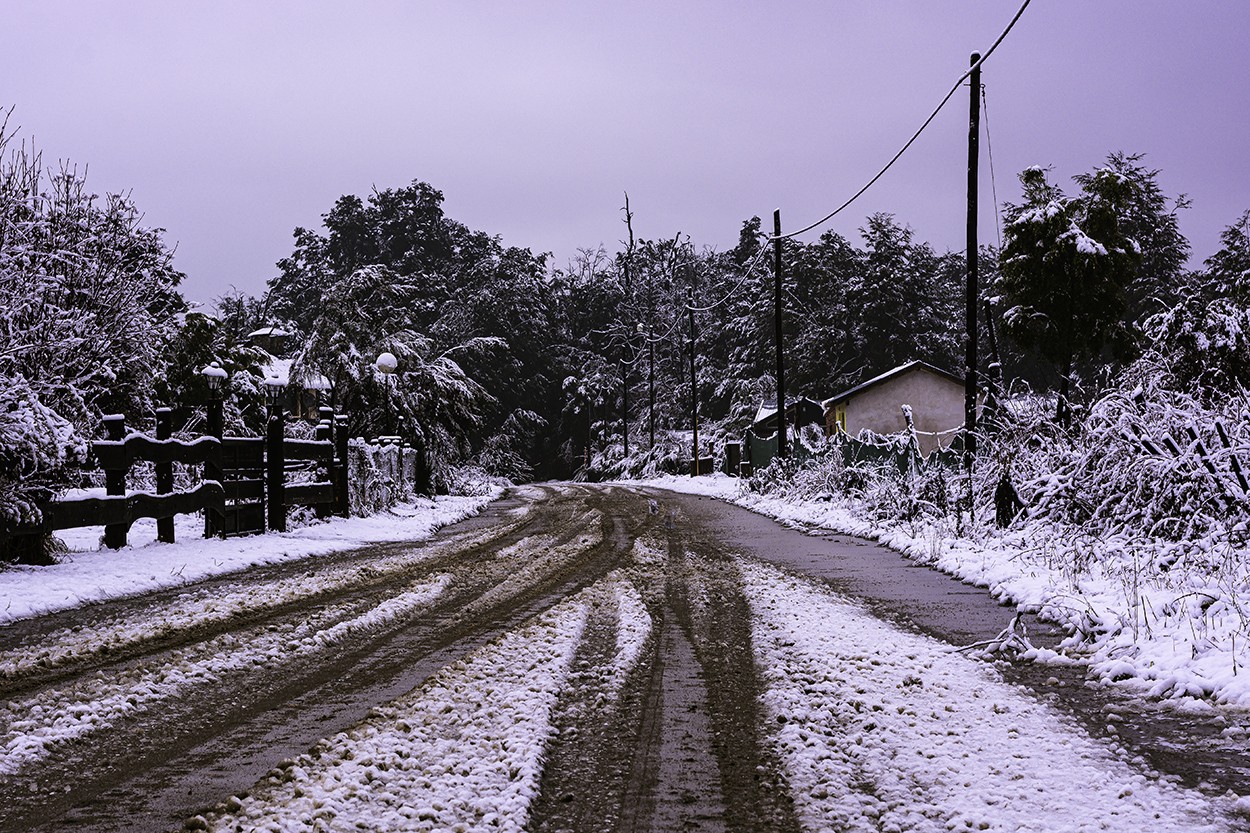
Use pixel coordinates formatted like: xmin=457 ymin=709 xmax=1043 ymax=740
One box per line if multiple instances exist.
xmin=824 ymin=361 xmax=964 ymax=455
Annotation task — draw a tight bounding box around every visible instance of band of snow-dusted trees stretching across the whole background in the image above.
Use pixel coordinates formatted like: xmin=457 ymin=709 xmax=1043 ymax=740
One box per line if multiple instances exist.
xmin=0 ymin=106 xmax=1250 ymax=522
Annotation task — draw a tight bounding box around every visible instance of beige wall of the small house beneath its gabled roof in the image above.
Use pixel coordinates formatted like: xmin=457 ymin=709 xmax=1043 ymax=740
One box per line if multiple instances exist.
xmin=830 ymin=368 xmax=964 ymax=454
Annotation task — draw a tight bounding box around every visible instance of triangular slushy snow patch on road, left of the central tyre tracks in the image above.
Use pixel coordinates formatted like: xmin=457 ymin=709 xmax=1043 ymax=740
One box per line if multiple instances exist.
xmin=196 ymin=582 xmax=589 ymax=833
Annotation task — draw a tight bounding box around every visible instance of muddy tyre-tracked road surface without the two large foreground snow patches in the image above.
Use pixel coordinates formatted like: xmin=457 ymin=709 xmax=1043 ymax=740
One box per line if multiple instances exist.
xmin=0 ymin=485 xmax=1250 ymax=832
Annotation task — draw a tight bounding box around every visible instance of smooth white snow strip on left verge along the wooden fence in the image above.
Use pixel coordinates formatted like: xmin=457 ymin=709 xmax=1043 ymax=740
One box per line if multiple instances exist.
xmin=0 ymin=488 xmax=501 ymax=624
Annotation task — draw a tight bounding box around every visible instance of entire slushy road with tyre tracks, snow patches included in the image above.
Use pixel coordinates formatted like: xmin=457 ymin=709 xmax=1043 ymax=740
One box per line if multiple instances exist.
xmin=0 ymin=487 xmax=1250 ymax=832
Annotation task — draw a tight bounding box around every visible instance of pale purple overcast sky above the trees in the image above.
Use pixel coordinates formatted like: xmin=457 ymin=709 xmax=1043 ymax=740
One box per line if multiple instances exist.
xmin=0 ymin=0 xmax=1250 ymax=301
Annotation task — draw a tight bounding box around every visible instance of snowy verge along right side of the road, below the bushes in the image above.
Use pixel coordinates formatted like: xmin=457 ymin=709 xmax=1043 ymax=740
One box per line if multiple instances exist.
xmin=646 ymin=474 xmax=1250 ymax=715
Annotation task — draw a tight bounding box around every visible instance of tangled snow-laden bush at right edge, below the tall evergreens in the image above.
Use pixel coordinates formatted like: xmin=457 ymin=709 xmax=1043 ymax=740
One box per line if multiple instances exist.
xmin=978 ymin=356 xmax=1250 ymax=540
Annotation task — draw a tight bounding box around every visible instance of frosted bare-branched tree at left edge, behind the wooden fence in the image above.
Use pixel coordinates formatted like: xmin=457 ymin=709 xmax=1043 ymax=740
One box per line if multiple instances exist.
xmin=0 ymin=113 xmax=185 ymax=542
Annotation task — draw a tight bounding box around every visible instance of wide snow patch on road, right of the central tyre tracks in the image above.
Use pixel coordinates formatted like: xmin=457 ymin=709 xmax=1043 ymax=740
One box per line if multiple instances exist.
xmin=741 ymin=560 xmax=1245 ymax=833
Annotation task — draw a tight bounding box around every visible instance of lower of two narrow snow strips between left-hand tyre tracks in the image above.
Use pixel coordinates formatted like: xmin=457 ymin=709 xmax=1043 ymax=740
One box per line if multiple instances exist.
xmin=0 ymin=574 xmax=451 ymax=775
